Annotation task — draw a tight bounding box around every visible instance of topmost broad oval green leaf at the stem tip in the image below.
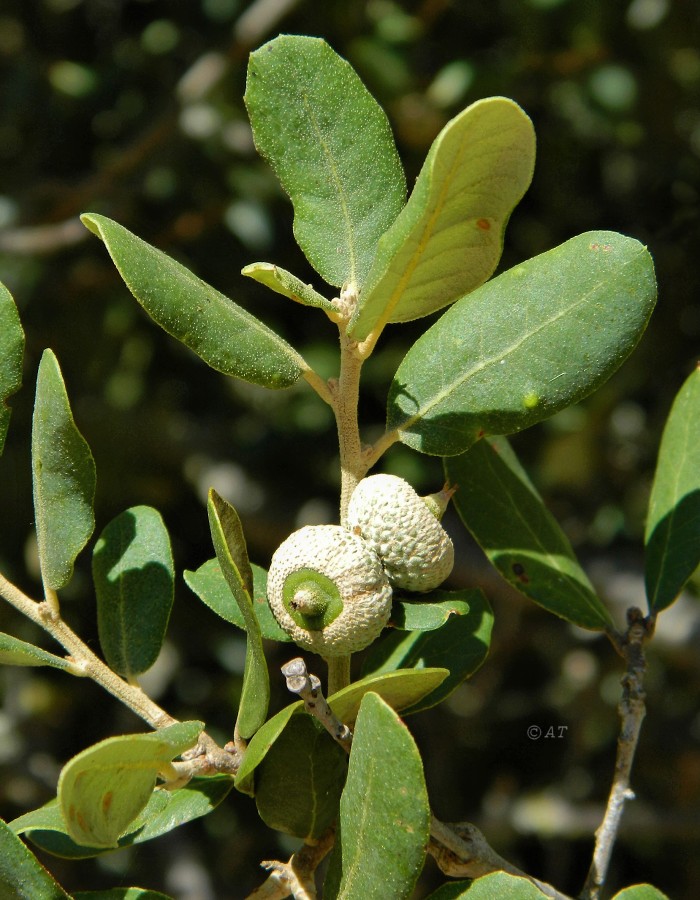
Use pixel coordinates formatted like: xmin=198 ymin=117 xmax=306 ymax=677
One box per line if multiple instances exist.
xmin=244 ymin=35 xmax=406 ymax=287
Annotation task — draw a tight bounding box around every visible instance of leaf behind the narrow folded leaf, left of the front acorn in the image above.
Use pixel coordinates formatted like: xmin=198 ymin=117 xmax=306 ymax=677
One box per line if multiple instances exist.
xmin=184 ymin=559 xmax=291 ymax=643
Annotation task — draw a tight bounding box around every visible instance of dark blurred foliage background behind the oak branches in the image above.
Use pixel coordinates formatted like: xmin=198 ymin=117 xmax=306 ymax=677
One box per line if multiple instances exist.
xmin=0 ymin=0 xmax=700 ymax=900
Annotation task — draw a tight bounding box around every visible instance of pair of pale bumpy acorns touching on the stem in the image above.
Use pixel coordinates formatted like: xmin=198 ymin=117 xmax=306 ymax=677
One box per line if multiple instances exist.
xmin=267 ymin=475 xmax=454 ymax=658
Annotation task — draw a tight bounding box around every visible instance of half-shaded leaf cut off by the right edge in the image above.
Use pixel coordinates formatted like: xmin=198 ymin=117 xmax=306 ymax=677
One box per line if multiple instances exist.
xmin=645 ymin=368 xmax=700 ymax=613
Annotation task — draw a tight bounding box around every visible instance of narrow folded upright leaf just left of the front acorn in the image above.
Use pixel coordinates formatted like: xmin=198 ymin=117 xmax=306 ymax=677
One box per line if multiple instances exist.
xmin=207 ymin=490 xmax=270 ymax=739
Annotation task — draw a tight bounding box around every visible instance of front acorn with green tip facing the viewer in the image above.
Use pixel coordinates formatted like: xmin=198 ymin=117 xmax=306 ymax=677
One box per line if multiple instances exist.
xmin=267 ymin=525 xmax=392 ymax=658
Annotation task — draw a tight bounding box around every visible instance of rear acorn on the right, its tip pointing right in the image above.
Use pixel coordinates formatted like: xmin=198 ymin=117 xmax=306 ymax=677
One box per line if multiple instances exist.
xmin=348 ymin=475 xmax=454 ymax=591
